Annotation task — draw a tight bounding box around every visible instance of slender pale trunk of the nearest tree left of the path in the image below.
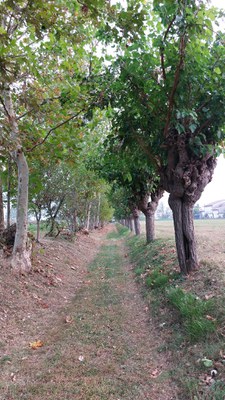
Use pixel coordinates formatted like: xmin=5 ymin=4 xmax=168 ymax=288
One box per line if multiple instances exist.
xmin=3 ymin=85 xmax=32 ymax=273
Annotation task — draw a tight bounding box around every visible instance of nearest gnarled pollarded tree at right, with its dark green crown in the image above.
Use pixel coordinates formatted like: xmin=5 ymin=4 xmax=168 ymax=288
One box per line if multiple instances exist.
xmin=103 ymin=0 xmax=225 ymax=274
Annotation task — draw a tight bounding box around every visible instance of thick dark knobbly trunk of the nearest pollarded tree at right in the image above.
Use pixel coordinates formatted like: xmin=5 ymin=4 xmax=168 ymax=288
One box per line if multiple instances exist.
xmin=161 ymin=132 xmax=216 ymax=275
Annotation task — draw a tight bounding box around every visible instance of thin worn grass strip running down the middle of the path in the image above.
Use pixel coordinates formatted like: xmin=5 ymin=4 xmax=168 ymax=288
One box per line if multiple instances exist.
xmin=3 ymin=225 xmax=163 ymax=400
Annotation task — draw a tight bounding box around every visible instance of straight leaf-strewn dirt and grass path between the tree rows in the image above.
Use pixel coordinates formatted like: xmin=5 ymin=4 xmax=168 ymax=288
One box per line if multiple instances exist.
xmin=0 ymin=227 xmax=178 ymax=400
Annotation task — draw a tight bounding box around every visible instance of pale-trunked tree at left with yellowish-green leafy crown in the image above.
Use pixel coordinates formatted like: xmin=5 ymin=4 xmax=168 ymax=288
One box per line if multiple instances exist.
xmin=0 ymin=0 xmax=111 ymax=273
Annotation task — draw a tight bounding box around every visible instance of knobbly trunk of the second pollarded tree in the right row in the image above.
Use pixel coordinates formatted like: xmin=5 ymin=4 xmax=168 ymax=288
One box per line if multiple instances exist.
xmin=138 ymin=187 xmax=163 ymax=243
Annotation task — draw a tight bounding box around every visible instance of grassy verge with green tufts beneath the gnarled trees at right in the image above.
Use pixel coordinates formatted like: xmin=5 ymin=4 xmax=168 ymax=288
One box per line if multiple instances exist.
xmin=127 ymin=231 xmax=225 ymax=400
